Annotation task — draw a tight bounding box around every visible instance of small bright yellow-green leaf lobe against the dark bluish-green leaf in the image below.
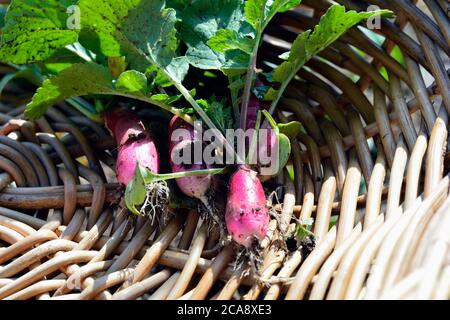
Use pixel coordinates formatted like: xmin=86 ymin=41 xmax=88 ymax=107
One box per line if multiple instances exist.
xmin=208 ymin=29 xmax=254 ymax=55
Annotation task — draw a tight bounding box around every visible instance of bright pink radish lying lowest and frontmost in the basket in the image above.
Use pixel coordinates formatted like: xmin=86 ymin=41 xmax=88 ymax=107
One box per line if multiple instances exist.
xmin=225 ymin=166 xmax=269 ymax=248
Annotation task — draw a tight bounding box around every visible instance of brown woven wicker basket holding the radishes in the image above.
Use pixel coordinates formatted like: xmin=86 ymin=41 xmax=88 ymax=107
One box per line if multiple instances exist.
xmin=0 ymin=0 xmax=450 ymax=300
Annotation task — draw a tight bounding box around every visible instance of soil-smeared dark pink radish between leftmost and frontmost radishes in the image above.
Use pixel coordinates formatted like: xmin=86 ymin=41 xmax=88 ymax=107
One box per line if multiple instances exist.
xmin=169 ymin=116 xmax=213 ymax=202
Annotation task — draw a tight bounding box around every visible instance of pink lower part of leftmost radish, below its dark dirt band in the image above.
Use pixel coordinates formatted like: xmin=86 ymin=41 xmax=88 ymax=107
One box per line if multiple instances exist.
xmin=116 ymin=136 xmax=159 ymax=185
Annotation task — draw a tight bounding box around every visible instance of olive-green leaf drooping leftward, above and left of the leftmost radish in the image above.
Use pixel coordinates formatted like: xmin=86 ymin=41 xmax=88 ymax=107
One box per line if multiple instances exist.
xmin=25 ymin=63 xmax=114 ymax=119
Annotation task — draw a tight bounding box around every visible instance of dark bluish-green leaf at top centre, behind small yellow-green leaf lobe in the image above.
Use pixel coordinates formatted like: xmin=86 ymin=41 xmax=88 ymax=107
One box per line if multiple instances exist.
xmin=180 ymin=0 xmax=245 ymax=69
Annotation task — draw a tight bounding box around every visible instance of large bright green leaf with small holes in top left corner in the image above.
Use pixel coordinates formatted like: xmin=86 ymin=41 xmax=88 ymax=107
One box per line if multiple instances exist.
xmin=0 ymin=0 xmax=78 ymax=64
